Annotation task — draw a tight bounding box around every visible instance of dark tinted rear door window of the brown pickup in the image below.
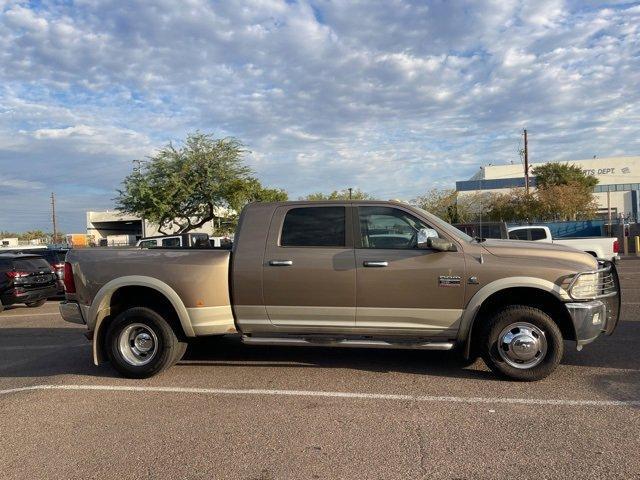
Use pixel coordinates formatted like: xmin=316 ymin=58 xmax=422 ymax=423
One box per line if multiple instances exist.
xmin=280 ymin=207 xmax=346 ymax=247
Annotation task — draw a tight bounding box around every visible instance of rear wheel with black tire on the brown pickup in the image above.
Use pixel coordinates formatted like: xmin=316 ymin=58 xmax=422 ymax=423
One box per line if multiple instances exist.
xmin=105 ymin=307 xmax=186 ymax=378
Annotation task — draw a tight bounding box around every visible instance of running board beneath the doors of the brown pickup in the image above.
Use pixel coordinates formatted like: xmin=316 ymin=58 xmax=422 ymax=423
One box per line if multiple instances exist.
xmin=242 ymin=335 xmax=455 ymax=350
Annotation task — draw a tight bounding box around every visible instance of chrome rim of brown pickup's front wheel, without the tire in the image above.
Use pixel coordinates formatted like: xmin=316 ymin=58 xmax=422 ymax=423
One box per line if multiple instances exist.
xmin=498 ymin=322 xmax=547 ymax=370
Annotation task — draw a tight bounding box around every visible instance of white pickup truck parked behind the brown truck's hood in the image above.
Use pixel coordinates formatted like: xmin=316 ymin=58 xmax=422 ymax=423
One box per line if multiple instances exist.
xmin=508 ymin=225 xmax=620 ymax=261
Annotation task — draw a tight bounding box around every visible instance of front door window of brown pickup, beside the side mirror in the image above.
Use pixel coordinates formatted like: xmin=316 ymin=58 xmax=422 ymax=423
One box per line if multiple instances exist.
xmin=358 ymin=207 xmax=431 ymax=249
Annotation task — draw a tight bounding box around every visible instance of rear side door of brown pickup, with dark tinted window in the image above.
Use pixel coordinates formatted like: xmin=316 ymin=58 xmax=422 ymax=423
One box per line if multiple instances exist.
xmin=263 ymin=204 xmax=356 ymax=329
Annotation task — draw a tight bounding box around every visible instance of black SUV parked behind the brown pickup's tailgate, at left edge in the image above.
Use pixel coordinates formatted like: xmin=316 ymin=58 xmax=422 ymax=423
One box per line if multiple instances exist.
xmin=0 ymin=253 xmax=58 ymax=311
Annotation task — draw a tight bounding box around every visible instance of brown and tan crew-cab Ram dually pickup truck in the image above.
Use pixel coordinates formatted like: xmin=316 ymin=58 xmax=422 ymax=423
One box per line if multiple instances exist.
xmin=60 ymin=201 xmax=620 ymax=380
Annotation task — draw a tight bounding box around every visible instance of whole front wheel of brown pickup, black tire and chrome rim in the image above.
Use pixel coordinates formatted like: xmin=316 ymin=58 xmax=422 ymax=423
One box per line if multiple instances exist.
xmin=480 ymin=305 xmax=564 ymax=381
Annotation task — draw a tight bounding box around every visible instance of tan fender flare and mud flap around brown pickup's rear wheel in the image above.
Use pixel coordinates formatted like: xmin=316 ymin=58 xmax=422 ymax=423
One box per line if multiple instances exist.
xmin=87 ymin=275 xmax=195 ymax=365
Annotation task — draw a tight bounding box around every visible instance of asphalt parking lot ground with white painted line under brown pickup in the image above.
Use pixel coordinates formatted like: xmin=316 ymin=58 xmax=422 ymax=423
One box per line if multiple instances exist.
xmin=0 ymin=260 xmax=640 ymax=479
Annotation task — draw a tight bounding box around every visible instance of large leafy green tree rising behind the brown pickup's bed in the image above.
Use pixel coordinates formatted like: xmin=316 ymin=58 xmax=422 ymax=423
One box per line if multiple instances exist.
xmin=115 ymin=132 xmax=286 ymax=234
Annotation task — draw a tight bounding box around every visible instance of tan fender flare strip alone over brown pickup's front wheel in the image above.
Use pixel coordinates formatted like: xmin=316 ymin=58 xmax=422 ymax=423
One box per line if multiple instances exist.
xmin=458 ymin=277 xmax=570 ymax=358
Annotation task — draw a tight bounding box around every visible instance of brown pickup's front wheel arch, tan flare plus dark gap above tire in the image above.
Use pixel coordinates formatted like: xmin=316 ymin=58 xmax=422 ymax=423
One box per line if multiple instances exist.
xmin=458 ymin=277 xmax=576 ymax=358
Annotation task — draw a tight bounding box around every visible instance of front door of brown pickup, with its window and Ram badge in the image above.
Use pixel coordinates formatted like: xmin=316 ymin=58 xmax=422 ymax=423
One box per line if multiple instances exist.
xmin=355 ymin=206 xmax=466 ymax=336
